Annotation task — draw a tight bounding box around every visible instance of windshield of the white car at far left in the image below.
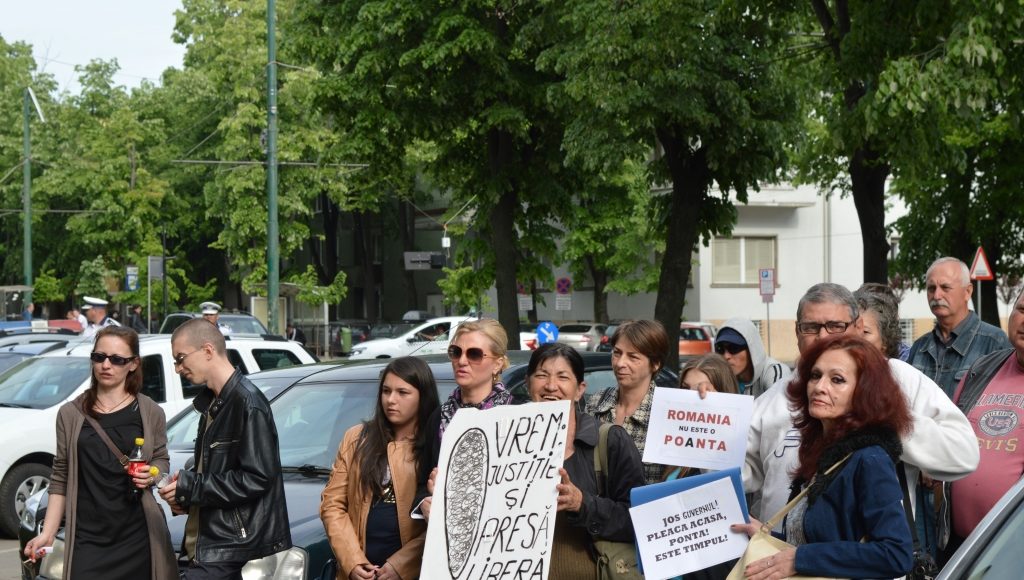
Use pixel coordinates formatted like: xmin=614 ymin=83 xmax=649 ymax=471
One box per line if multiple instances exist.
xmin=0 ymin=357 xmax=90 ymax=409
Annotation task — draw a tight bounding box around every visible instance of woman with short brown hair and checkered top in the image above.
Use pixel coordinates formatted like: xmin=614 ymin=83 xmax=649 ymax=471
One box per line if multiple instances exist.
xmin=587 ymin=320 xmax=675 ymax=484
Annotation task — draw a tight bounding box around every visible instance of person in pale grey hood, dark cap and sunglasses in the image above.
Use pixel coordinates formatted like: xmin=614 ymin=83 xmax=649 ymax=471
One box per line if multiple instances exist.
xmin=715 ymin=318 xmax=793 ymax=397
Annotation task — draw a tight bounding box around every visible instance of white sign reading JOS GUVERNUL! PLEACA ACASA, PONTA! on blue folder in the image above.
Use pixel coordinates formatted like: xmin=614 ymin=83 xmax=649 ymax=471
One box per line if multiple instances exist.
xmin=630 ymin=478 xmax=749 ymax=580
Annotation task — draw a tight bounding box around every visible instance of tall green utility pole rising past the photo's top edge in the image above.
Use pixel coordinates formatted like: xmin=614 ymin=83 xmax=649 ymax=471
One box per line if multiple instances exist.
xmin=266 ymin=0 xmax=281 ymax=334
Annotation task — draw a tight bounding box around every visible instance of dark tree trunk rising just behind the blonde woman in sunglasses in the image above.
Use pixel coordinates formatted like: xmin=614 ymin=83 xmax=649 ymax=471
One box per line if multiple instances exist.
xmin=487 ymin=129 xmax=519 ymax=347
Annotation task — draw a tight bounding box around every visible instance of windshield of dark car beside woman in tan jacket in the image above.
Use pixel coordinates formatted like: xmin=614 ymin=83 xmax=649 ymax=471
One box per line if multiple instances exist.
xmin=270 ymin=382 xmax=377 ymax=469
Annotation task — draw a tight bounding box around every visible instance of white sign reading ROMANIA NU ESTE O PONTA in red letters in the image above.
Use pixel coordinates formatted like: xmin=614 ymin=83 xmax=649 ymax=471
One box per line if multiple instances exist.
xmin=643 ymin=387 xmax=754 ymax=469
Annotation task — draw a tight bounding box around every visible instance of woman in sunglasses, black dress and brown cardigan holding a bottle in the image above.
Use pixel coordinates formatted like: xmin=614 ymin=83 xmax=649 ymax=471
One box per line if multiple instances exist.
xmin=25 ymin=326 xmax=178 ymax=580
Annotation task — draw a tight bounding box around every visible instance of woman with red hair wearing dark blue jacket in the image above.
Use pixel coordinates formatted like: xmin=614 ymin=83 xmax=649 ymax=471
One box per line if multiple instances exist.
xmin=732 ymin=334 xmax=913 ymax=580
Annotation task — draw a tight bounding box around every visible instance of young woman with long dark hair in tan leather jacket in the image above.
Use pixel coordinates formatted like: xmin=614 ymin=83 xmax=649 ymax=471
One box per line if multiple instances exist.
xmin=321 ymin=357 xmax=438 ymax=580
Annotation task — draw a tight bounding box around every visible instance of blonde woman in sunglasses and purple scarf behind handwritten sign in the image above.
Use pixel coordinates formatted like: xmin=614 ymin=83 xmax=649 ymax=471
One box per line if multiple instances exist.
xmin=414 ymin=319 xmax=512 ymax=516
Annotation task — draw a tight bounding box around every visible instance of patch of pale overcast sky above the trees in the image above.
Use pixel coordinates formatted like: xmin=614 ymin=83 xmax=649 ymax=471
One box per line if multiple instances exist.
xmin=0 ymin=0 xmax=184 ymax=93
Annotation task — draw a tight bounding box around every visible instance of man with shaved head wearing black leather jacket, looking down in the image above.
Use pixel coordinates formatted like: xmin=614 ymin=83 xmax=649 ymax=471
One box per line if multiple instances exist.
xmin=160 ymin=319 xmax=292 ymax=580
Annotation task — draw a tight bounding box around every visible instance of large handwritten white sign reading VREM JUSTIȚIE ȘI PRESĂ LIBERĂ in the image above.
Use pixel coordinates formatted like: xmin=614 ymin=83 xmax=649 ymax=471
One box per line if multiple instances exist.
xmin=420 ymin=401 xmax=569 ymax=580
